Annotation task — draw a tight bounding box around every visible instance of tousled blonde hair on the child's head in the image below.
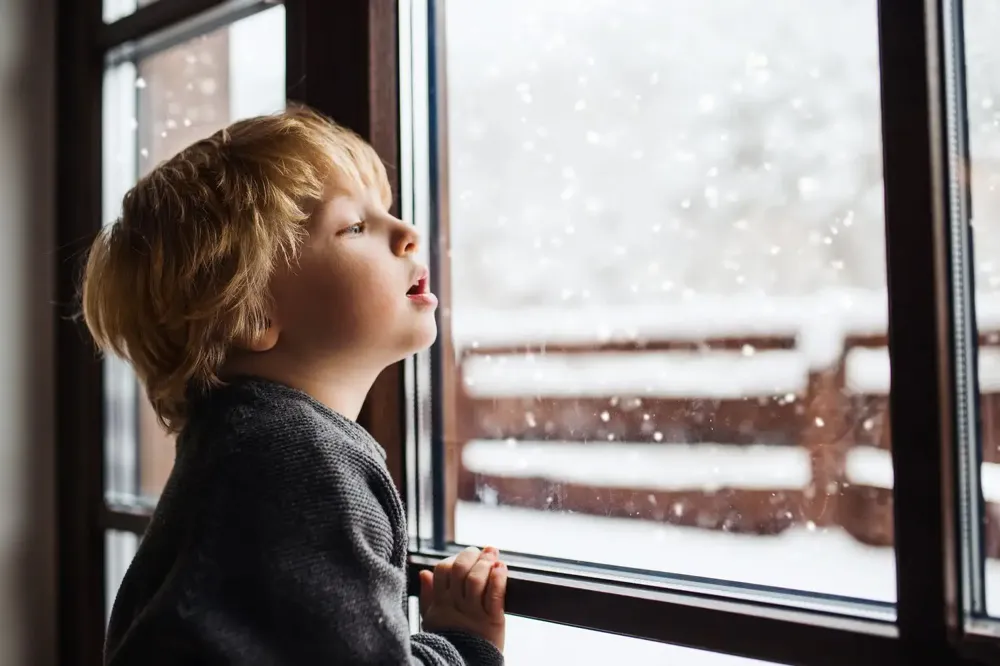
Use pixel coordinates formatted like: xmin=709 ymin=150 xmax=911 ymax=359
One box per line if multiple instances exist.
xmin=81 ymin=107 xmax=391 ymax=432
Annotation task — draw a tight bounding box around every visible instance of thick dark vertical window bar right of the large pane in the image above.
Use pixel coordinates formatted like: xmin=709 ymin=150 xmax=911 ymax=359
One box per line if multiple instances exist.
xmin=878 ymin=0 xmax=960 ymax=664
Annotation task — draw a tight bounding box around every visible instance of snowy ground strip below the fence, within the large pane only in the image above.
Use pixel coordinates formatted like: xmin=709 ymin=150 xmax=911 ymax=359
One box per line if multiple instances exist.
xmin=455 ymin=503 xmax=896 ymax=602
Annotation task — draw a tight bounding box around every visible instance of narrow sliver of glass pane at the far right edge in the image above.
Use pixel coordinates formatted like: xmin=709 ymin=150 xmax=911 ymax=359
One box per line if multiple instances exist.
xmin=964 ymin=2 xmax=1000 ymax=615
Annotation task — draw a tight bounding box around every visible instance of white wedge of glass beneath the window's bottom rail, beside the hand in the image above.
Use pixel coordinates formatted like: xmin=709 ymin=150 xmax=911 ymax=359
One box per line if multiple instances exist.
xmin=496 ymin=615 xmax=770 ymax=666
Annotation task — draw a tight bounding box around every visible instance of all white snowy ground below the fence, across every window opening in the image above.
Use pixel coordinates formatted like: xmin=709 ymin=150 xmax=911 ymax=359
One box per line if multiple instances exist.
xmin=455 ymin=502 xmax=1000 ymax=666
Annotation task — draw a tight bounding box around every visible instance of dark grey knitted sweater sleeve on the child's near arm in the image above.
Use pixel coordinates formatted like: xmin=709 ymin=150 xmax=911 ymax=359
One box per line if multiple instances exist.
xmin=169 ymin=430 xmax=503 ymax=666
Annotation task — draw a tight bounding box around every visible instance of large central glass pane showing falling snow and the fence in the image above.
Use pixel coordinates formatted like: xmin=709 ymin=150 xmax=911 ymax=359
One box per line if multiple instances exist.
xmin=430 ymin=0 xmax=895 ymax=602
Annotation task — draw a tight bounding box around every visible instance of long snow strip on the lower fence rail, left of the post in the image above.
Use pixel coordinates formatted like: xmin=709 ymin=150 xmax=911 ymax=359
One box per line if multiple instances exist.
xmin=462 ymin=440 xmax=812 ymax=490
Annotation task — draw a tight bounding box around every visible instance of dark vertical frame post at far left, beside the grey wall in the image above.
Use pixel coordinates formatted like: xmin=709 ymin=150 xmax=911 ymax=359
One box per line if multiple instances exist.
xmin=54 ymin=0 xmax=104 ymax=666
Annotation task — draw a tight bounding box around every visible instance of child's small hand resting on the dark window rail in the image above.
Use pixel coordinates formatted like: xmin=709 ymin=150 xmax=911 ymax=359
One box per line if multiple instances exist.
xmin=420 ymin=546 xmax=507 ymax=652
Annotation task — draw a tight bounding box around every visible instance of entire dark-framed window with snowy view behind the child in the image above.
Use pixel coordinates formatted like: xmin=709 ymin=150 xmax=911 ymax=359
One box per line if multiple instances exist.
xmin=57 ymin=0 xmax=1000 ymax=666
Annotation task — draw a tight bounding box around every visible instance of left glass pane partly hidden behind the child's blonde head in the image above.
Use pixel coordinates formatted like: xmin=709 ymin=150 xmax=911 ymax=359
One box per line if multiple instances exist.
xmin=104 ymin=5 xmax=285 ymax=498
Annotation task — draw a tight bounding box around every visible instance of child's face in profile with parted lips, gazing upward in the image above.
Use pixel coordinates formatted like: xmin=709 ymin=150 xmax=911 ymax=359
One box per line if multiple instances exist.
xmin=272 ymin=182 xmax=437 ymax=370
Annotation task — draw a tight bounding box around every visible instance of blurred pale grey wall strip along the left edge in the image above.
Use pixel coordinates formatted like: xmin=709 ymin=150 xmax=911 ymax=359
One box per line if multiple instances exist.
xmin=0 ymin=0 xmax=56 ymax=666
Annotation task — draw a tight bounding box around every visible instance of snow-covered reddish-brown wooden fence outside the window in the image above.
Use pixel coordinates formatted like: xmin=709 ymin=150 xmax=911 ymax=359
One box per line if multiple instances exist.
xmin=449 ymin=292 xmax=1000 ymax=554
